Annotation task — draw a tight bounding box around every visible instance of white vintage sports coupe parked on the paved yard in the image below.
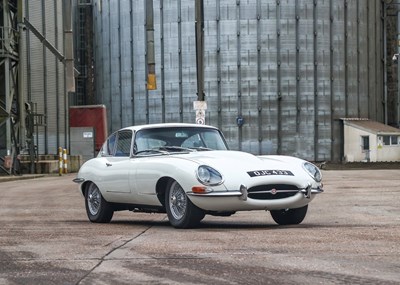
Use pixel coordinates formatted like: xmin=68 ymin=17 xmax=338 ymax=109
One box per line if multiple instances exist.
xmin=74 ymin=124 xmax=323 ymax=228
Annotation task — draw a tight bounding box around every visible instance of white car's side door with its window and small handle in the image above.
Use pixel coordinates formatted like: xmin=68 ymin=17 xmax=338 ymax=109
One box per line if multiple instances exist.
xmin=99 ymin=130 xmax=132 ymax=193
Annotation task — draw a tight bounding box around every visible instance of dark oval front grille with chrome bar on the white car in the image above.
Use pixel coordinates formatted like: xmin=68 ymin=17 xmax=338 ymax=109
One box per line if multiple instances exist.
xmin=247 ymin=184 xmax=299 ymax=200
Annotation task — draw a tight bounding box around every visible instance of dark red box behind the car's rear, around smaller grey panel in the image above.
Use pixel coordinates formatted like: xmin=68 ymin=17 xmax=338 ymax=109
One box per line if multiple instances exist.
xmin=69 ymin=105 xmax=107 ymax=152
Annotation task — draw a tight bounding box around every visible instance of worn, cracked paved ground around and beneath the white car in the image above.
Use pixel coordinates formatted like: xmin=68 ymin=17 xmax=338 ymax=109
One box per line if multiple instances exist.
xmin=0 ymin=169 xmax=400 ymax=285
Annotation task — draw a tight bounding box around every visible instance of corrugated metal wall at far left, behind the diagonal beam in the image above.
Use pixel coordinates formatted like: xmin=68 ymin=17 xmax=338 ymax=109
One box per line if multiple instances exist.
xmin=21 ymin=0 xmax=68 ymax=154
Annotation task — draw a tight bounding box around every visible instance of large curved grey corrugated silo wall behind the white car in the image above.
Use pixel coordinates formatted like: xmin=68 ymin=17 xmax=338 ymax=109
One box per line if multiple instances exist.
xmin=93 ymin=0 xmax=384 ymax=161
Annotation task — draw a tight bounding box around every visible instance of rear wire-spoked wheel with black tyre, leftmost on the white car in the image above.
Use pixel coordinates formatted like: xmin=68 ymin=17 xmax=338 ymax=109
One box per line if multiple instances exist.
xmin=85 ymin=183 xmax=114 ymax=223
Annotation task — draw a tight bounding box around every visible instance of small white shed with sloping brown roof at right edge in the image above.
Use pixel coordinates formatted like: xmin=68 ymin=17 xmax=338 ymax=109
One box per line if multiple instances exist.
xmin=342 ymin=118 xmax=400 ymax=162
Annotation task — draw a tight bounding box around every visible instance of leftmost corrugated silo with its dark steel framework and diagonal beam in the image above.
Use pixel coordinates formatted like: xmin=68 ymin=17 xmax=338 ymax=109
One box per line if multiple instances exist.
xmin=0 ymin=0 xmax=74 ymax=174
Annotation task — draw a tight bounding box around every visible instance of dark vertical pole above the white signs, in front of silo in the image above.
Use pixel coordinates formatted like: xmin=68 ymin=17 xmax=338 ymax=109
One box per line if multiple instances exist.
xmin=195 ymin=0 xmax=205 ymax=101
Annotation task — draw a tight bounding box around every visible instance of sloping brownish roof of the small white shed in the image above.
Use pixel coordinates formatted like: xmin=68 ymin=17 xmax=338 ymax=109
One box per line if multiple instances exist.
xmin=342 ymin=118 xmax=400 ymax=135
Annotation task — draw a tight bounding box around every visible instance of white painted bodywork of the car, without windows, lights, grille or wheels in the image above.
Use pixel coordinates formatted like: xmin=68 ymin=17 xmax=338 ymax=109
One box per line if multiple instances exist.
xmin=77 ymin=124 xmax=322 ymax=212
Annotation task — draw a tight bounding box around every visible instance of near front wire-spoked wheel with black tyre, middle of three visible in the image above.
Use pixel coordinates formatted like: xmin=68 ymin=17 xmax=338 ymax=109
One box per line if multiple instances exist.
xmin=165 ymin=181 xmax=205 ymax=229
